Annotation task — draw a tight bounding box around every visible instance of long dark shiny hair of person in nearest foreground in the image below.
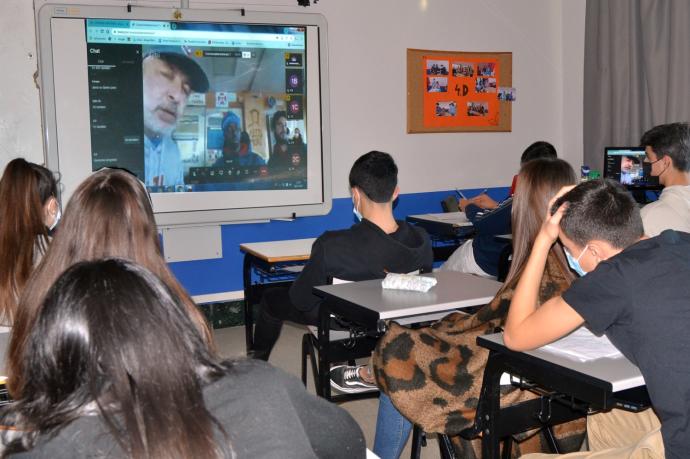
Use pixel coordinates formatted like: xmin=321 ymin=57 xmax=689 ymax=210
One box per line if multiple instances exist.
xmin=3 ymin=258 xmax=229 ymax=458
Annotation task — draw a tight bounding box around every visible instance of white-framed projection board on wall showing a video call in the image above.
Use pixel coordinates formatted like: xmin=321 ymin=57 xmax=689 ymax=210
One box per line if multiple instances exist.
xmin=38 ymin=5 xmax=331 ymax=225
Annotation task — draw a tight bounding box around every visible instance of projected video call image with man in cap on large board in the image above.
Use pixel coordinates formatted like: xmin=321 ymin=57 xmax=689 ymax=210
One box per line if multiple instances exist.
xmin=86 ymin=19 xmax=307 ymax=193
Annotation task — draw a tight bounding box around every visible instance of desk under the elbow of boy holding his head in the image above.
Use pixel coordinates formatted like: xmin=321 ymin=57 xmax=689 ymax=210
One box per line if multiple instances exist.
xmin=471 ymin=333 xmax=650 ymax=458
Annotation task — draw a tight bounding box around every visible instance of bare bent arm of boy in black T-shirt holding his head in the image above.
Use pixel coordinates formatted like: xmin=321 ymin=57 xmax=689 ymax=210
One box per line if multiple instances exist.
xmin=503 ymin=206 xmax=584 ymax=351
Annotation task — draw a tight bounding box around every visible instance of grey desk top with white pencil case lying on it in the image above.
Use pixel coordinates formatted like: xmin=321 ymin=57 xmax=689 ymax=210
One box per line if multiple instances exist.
xmin=317 ymin=271 xmax=501 ymax=319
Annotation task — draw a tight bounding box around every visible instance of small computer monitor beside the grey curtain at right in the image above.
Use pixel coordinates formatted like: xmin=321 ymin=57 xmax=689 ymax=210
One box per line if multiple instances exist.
xmin=604 ymin=147 xmax=659 ymax=189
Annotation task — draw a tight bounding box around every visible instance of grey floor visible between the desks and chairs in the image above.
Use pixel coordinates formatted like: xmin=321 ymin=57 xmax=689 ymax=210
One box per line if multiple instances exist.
xmin=215 ymin=324 xmax=439 ymax=459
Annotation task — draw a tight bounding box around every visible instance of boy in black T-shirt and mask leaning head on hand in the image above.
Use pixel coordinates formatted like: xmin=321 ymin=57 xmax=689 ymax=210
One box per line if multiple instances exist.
xmin=503 ymin=180 xmax=690 ymax=458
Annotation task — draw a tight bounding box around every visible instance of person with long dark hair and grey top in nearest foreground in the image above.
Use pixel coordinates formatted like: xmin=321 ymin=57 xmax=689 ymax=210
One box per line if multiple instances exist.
xmin=1 ymin=258 xmax=365 ymax=459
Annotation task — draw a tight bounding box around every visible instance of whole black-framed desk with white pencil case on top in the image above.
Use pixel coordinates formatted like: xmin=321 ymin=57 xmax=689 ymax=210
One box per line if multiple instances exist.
xmin=314 ymin=271 xmax=501 ymax=400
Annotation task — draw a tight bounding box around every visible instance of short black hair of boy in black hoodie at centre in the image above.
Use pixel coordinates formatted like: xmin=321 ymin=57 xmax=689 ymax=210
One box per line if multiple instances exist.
xmin=350 ymin=151 xmax=398 ymax=203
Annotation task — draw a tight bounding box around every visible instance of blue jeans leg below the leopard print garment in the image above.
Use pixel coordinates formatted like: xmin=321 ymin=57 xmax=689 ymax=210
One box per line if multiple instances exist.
xmin=374 ymin=392 xmax=412 ymax=459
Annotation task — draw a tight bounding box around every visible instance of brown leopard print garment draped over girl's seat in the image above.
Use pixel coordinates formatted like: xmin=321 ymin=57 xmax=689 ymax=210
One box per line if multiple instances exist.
xmin=372 ymin=251 xmax=584 ymax=457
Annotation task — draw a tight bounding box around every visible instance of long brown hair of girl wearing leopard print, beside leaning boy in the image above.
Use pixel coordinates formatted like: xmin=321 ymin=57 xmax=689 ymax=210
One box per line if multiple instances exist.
xmin=502 ymin=158 xmax=577 ymax=290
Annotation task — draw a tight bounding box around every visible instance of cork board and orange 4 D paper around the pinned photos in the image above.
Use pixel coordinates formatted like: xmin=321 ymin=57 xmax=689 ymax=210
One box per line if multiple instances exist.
xmin=407 ymin=49 xmax=513 ymax=134
